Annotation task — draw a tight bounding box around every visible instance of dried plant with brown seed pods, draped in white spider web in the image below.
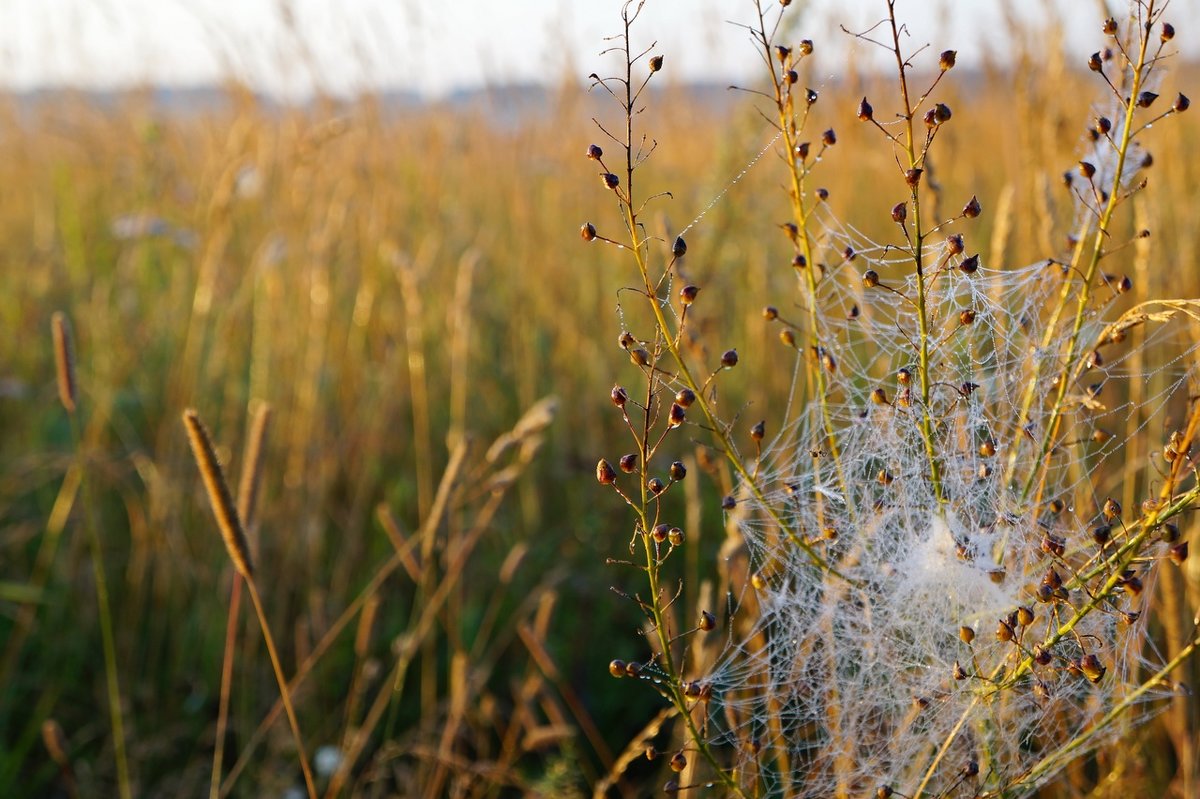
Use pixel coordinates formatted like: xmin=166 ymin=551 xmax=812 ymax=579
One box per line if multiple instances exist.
xmin=581 ymin=0 xmax=1200 ymax=798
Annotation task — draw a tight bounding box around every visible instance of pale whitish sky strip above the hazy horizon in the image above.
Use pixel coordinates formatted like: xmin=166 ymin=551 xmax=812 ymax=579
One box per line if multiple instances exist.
xmin=0 ymin=0 xmax=1200 ymax=97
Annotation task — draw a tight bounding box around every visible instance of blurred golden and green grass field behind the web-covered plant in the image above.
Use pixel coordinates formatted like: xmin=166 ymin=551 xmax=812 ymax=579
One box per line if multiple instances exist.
xmin=0 ymin=10 xmax=1200 ymax=797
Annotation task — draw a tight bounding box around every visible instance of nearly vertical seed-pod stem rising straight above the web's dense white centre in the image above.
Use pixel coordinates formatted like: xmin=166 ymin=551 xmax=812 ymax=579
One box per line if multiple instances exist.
xmin=888 ymin=0 xmax=944 ymax=503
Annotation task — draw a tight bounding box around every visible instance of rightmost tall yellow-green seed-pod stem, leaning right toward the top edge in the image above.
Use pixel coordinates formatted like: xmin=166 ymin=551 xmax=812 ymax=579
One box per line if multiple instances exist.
xmin=1020 ymin=0 xmax=1154 ymax=504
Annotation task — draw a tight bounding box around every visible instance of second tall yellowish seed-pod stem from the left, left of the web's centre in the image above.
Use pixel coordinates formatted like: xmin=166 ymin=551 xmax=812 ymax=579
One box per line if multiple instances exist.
xmin=756 ymin=2 xmax=850 ymax=511
